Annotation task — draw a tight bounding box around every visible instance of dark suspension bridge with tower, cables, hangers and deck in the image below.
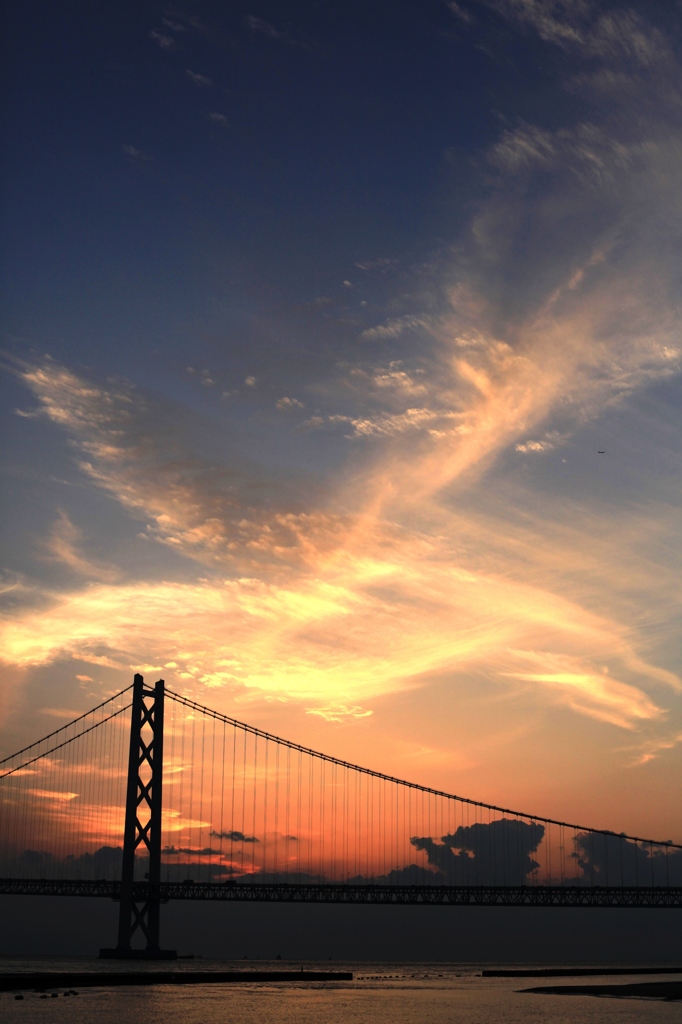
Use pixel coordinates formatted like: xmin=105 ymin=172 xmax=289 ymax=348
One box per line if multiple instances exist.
xmin=0 ymin=675 xmax=682 ymax=958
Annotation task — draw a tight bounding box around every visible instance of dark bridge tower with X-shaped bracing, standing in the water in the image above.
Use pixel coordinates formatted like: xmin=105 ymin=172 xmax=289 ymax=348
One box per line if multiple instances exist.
xmin=99 ymin=674 xmax=177 ymax=959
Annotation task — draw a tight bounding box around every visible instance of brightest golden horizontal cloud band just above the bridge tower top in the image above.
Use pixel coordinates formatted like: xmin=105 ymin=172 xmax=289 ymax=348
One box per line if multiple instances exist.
xmin=1 ymin=520 xmax=680 ymax=727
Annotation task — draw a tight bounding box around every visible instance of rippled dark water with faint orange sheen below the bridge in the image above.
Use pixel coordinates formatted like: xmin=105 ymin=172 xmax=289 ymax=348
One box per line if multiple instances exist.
xmin=0 ymin=957 xmax=682 ymax=1024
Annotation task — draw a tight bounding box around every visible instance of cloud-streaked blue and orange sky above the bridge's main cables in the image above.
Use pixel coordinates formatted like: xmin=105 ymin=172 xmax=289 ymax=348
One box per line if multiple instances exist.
xmin=0 ymin=0 xmax=682 ymax=842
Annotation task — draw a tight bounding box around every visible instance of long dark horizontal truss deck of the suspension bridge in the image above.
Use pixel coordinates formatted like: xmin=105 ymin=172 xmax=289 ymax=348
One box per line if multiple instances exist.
xmin=0 ymin=879 xmax=682 ymax=909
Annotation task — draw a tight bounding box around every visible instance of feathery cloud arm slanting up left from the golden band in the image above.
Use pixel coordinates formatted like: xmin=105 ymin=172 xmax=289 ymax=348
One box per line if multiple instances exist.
xmin=11 ymin=360 xmax=346 ymax=569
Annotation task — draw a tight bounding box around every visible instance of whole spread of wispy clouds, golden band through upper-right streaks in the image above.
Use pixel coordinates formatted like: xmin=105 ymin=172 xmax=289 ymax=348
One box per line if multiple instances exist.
xmin=5 ymin=0 xmax=682 ymax=756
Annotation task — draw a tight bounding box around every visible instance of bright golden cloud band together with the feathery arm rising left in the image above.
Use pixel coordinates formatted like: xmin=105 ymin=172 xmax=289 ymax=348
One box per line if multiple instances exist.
xmin=2 ymin=342 xmax=679 ymax=728
